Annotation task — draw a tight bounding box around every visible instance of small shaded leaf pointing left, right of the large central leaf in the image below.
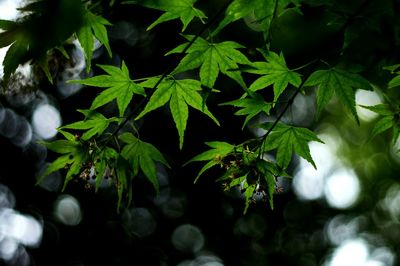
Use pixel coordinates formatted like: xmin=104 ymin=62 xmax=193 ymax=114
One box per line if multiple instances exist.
xmin=221 ymin=94 xmax=272 ymax=130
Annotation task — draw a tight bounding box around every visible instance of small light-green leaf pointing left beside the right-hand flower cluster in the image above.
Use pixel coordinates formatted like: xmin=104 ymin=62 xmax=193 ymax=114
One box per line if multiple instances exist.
xmin=184 ymin=141 xmax=235 ymax=183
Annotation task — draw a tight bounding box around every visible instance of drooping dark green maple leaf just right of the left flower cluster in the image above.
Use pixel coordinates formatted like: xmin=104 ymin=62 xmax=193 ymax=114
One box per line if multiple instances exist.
xmin=119 ymin=132 xmax=169 ymax=194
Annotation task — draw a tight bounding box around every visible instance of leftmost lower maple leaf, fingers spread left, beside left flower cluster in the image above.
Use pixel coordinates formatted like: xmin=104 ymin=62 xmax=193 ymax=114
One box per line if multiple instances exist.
xmin=38 ymin=131 xmax=89 ymax=190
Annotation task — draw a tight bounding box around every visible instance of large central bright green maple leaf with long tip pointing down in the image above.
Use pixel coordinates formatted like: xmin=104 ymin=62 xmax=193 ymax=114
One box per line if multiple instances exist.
xmin=136 ymin=79 xmax=219 ymax=149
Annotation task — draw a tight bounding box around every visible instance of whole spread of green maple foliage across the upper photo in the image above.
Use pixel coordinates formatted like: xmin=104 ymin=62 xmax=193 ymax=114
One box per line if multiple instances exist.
xmin=0 ymin=0 xmax=400 ymax=212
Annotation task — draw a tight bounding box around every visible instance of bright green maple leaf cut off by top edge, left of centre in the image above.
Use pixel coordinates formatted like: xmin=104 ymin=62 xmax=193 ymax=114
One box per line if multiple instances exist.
xmin=123 ymin=0 xmax=207 ymax=32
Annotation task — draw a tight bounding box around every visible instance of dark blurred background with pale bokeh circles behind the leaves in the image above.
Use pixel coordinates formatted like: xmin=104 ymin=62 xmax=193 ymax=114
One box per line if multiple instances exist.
xmin=0 ymin=0 xmax=400 ymax=266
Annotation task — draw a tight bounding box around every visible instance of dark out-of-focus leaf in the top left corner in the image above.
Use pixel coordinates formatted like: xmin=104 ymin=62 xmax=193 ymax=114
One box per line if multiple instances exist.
xmin=0 ymin=0 xmax=82 ymax=79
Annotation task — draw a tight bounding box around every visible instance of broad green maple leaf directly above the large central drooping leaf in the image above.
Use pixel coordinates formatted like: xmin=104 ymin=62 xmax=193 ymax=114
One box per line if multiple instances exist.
xmin=166 ymin=35 xmax=250 ymax=88
